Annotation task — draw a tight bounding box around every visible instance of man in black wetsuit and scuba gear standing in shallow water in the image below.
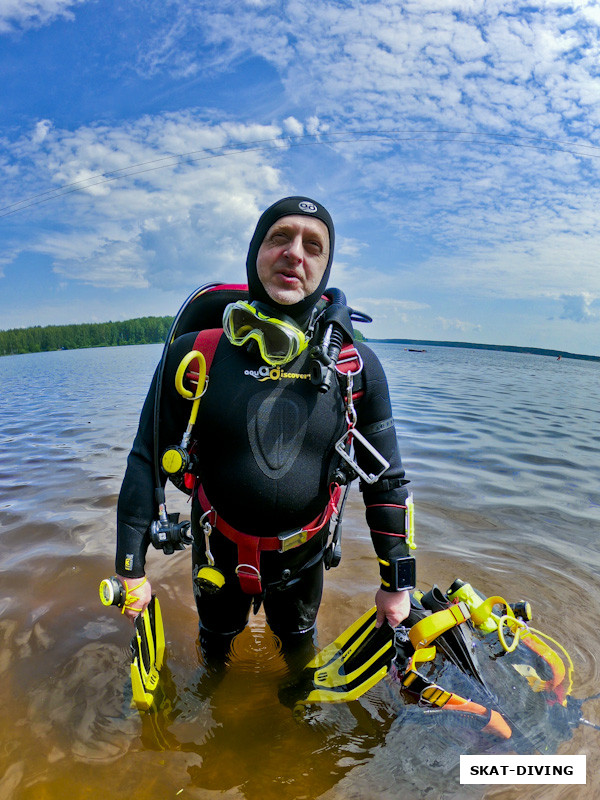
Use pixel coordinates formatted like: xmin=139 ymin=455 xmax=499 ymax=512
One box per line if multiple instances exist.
xmin=110 ymin=197 xmax=415 ymax=658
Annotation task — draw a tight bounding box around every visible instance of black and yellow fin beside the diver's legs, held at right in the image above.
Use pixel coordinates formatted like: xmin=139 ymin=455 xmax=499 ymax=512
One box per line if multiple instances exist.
xmin=296 ymin=607 xmax=395 ymax=706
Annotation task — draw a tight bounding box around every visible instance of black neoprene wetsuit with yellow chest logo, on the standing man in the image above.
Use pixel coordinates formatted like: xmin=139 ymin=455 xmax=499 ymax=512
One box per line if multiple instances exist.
xmin=116 ymin=324 xmax=408 ymax=637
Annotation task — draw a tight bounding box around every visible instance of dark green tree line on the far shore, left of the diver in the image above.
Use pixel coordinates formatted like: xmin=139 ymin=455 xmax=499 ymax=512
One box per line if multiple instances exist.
xmin=0 ymin=317 xmax=173 ymax=356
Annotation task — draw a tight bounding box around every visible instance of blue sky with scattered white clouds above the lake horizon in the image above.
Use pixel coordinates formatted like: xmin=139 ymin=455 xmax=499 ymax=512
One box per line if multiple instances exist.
xmin=0 ymin=0 xmax=600 ymax=355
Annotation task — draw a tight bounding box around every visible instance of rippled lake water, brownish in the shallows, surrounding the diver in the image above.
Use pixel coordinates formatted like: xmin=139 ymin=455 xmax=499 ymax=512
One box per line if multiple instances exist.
xmin=0 ymin=344 xmax=600 ymax=800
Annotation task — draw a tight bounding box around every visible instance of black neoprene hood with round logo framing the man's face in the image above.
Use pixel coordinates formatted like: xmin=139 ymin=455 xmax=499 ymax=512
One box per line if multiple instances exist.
xmin=246 ymin=197 xmax=335 ymax=322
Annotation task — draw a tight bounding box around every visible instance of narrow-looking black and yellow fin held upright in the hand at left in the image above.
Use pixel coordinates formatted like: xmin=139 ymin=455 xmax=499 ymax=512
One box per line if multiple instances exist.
xmin=130 ymin=596 xmax=165 ymax=711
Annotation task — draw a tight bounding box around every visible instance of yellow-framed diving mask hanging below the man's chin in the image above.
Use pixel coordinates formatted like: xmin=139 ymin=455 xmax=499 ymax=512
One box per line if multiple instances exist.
xmin=223 ymin=300 xmax=309 ymax=367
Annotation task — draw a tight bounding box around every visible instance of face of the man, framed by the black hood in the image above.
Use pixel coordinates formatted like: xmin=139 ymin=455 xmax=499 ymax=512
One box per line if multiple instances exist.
xmin=256 ymin=214 xmax=329 ymax=306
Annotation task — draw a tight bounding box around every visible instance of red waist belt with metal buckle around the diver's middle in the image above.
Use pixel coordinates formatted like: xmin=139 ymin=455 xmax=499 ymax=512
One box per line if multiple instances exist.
xmin=198 ymin=484 xmax=342 ymax=595
